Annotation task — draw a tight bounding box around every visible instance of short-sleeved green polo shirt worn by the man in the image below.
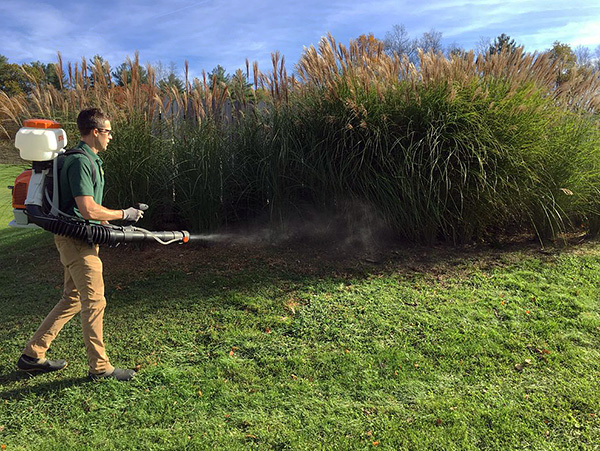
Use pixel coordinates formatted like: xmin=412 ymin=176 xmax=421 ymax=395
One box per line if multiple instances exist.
xmin=59 ymin=141 xmax=104 ymax=223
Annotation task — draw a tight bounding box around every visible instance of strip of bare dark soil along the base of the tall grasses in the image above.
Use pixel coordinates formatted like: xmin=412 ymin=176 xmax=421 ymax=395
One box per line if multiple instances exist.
xmin=101 ymin=234 xmax=597 ymax=284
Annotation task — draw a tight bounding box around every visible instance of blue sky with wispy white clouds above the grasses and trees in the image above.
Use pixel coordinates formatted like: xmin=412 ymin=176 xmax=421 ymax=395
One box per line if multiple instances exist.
xmin=0 ymin=0 xmax=600 ymax=75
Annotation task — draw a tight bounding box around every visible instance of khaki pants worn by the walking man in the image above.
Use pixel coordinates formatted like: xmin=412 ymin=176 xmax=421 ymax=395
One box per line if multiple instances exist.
xmin=23 ymin=235 xmax=113 ymax=373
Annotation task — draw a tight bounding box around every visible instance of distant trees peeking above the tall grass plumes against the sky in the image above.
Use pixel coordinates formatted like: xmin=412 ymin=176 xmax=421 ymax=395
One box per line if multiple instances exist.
xmin=0 ymin=24 xmax=600 ymax=97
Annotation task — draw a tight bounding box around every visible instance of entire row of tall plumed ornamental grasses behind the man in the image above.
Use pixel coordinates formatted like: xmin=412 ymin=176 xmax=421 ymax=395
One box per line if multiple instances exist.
xmin=0 ymin=36 xmax=600 ymax=243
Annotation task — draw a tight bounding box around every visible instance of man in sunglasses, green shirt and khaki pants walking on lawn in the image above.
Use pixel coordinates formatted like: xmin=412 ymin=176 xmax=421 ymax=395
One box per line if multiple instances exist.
xmin=17 ymin=108 xmax=143 ymax=381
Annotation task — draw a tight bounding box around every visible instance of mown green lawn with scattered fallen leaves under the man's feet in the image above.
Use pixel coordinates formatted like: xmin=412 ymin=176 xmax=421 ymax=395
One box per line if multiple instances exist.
xmin=0 ymin=166 xmax=600 ymax=450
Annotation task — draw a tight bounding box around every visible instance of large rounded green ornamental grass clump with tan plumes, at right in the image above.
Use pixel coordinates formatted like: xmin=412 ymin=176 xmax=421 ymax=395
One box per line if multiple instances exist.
xmin=288 ymin=37 xmax=600 ymax=242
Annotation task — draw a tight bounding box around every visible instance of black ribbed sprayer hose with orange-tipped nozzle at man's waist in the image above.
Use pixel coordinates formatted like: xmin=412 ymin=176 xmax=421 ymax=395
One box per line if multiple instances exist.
xmin=25 ymin=205 xmax=190 ymax=246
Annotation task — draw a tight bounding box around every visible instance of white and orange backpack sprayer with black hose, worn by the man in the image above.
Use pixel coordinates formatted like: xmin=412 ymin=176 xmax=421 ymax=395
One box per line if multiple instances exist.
xmin=9 ymin=119 xmax=190 ymax=246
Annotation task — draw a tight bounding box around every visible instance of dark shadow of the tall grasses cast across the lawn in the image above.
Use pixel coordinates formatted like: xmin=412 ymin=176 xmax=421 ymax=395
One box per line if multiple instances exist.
xmin=0 ymin=222 xmax=592 ymax=324
